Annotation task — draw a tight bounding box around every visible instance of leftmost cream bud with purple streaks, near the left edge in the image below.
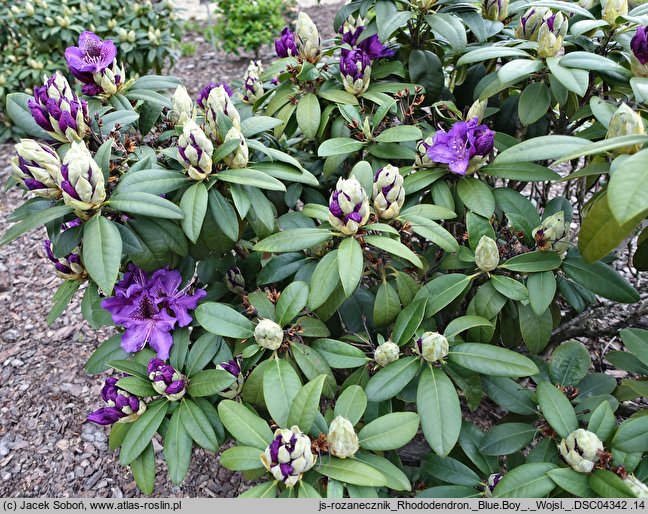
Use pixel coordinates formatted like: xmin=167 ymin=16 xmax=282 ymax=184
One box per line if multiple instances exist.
xmin=11 ymin=139 xmax=61 ymax=200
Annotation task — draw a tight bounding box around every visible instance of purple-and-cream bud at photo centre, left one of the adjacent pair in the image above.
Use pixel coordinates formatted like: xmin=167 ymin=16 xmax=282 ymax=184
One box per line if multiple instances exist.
xmin=328 ymin=177 xmax=369 ymax=235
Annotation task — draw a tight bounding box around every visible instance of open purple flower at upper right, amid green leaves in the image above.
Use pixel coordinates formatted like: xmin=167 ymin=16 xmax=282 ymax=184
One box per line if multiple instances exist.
xmin=427 ymin=118 xmax=495 ymax=175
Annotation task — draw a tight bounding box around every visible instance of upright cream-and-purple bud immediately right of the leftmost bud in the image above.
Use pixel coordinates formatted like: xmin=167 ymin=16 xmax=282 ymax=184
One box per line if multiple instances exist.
xmin=57 ymin=142 xmax=106 ymax=211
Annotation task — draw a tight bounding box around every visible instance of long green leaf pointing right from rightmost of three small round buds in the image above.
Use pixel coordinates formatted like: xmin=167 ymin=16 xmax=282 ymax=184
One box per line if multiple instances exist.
xmin=448 ymin=343 xmax=538 ymax=378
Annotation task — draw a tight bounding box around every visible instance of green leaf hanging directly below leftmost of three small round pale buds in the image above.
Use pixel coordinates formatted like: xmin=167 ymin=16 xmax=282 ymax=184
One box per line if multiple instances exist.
xmin=263 ymin=358 xmax=302 ymax=427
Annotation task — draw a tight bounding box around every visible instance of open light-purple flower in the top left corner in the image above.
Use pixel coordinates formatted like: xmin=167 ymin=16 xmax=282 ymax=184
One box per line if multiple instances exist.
xmin=65 ymin=31 xmax=117 ymax=84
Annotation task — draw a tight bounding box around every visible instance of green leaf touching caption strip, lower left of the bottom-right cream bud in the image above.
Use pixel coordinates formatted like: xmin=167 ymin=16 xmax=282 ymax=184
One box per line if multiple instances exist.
xmin=493 ymin=462 xmax=557 ymax=498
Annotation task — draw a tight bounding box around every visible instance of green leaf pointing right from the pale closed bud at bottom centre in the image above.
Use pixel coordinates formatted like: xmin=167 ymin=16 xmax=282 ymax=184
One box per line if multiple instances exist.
xmin=358 ymin=412 xmax=420 ymax=451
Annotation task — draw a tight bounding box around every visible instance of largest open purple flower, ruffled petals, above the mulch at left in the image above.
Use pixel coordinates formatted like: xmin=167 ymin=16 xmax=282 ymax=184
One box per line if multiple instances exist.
xmin=101 ymin=263 xmax=207 ymax=359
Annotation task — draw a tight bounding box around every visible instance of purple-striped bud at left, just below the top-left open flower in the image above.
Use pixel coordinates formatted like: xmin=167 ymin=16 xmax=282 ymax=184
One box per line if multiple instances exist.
xmin=27 ymin=72 xmax=88 ymax=143
